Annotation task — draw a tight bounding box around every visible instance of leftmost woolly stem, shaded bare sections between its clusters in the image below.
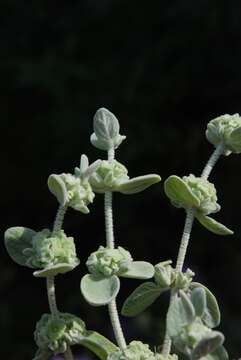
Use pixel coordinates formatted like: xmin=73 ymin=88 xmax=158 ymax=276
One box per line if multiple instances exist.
xmin=47 ymin=205 xmax=74 ymax=360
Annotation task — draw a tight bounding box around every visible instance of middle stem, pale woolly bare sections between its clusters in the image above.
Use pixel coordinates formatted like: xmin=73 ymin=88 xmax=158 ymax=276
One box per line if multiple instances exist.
xmin=104 ymin=149 xmax=126 ymax=352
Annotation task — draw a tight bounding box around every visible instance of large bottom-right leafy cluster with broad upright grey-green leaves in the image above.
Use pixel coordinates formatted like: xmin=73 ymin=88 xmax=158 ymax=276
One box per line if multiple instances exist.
xmin=167 ymin=287 xmax=225 ymax=360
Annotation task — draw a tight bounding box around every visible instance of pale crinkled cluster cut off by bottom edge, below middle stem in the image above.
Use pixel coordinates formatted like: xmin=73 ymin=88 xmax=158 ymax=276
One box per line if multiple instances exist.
xmin=107 ymin=341 xmax=177 ymax=360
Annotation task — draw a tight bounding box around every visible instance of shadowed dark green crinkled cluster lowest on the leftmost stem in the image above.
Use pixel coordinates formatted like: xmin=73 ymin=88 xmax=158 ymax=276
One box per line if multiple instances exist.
xmin=34 ymin=313 xmax=86 ymax=354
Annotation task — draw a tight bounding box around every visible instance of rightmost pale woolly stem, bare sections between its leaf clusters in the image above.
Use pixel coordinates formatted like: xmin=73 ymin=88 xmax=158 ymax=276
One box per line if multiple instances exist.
xmin=162 ymin=144 xmax=224 ymax=359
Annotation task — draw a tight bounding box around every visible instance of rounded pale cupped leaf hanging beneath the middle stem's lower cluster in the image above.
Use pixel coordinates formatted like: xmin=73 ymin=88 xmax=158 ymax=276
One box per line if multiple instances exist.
xmin=80 ymin=274 xmax=120 ymax=306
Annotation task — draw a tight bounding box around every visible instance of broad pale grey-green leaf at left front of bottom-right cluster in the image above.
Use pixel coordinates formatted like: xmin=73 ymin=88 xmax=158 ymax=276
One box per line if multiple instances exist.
xmin=167 ymin=291 xmax=195 ymax=338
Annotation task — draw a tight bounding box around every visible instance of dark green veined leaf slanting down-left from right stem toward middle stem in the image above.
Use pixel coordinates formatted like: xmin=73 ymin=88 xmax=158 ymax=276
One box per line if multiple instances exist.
xmin=121 ymin=282 xmax=164 ymax=316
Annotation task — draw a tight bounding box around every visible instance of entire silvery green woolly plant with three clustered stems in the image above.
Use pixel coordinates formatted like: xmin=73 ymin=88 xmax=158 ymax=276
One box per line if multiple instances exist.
xmin=5 ymin=108 xmax=241 ymax=360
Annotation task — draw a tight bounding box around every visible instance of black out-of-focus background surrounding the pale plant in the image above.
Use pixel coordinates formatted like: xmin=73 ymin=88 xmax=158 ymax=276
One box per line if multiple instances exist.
xmin=0 ymin=0 xmax=241 ymax=360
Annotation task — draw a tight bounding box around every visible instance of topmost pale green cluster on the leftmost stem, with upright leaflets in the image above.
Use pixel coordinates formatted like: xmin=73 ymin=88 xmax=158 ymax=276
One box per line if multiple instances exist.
xmin=48 ymin=155 xmax=97 ymax=214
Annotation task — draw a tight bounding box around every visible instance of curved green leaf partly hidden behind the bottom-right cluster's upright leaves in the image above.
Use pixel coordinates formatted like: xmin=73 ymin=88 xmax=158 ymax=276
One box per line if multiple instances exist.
xmin=190 ymin=282 xmax=221 ymax=329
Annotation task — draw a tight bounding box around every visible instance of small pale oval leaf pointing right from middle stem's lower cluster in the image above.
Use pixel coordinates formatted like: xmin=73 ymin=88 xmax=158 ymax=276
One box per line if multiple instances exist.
xmin=119 ymin=261 xmax=155 ymax=279
